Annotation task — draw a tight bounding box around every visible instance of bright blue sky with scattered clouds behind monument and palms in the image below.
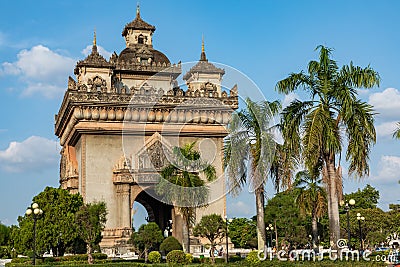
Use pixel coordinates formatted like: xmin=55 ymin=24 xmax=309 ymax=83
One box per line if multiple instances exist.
xmin=0 ymin=0 xmax=400 ymax=224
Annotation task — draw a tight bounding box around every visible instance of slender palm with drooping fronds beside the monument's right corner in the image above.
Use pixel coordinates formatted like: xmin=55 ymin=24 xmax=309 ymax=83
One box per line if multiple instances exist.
xmin=224 ymin=99 xmax=281 ymax=249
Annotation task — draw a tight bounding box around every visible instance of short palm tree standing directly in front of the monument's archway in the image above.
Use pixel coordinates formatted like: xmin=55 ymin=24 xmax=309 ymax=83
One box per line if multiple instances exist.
xmin=156 ymin=142 xmax=216 ymax=253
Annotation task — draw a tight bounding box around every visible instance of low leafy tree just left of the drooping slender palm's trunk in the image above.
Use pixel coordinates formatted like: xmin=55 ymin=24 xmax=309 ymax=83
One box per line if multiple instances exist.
xmin=228 ymin=218 xmax=257 ymax=248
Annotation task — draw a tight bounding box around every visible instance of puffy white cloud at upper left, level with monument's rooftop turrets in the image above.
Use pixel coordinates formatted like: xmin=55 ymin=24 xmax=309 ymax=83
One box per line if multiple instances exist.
xmin=0 ymin=45 xmax=76 ymax=98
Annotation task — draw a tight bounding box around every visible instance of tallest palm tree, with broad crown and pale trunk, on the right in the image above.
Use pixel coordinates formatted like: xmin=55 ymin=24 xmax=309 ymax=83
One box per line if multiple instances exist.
xmin=276 ymin=46 xmax=380 ymax=249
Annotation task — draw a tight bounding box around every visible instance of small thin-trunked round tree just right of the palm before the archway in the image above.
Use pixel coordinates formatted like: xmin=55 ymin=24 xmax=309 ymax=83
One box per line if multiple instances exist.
xmin=193 ymin=214 xmax=226 ymax=263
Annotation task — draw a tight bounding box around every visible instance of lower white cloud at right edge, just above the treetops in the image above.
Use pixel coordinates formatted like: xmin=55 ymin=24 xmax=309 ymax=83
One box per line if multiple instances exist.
xmin=371 ymin=155 xmax=400 ymax=186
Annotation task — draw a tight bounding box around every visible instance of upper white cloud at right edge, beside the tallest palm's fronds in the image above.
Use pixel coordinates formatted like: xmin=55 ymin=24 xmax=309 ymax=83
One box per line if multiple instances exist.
xmin=368 ymin=88 xmax=400 ymax=118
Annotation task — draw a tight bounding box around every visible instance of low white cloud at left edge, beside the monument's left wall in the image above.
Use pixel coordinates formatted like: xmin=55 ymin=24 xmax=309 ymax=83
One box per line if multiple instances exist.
xmin=0 ymin=136 xmax=59 ymax=172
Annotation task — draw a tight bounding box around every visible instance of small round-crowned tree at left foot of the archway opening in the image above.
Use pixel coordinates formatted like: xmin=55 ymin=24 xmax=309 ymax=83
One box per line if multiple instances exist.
xmin=132 ymin=222 xmax=164 ymax=262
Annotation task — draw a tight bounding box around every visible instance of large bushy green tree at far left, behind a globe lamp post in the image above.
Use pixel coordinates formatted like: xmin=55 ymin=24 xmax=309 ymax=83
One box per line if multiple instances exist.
xmin=12 ymin=187 xmax=83 ymax=256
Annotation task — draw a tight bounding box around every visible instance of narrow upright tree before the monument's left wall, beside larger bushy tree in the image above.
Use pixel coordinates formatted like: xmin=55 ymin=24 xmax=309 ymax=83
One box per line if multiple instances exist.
xmin=75 ymin=202 xmax=107 ymax=264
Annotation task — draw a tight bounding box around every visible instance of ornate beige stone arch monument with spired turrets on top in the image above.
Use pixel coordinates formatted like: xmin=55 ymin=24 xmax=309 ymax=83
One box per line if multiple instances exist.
xmin=55 ymin=9 xmax=238 ymax=254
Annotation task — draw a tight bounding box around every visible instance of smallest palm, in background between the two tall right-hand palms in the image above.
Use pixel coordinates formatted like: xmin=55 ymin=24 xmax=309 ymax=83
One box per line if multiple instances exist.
xmin=293 ymin=170 xmax=327 ymax=249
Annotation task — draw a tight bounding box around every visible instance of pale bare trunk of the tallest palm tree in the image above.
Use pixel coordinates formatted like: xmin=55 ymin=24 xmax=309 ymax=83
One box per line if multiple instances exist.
xmin=326 ymin=158 xmax=340 ymax=249
